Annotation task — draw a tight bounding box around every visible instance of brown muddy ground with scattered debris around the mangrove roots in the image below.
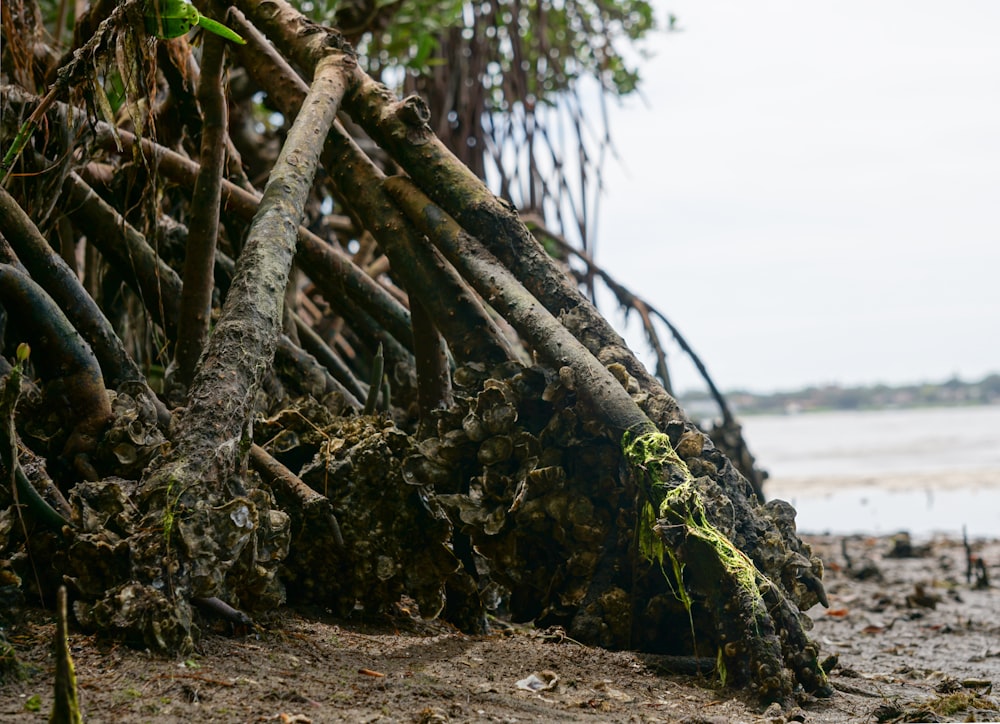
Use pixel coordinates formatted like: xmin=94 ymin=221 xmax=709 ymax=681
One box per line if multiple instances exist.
xmin=0 ymin=537 xmax=1000 ymax=724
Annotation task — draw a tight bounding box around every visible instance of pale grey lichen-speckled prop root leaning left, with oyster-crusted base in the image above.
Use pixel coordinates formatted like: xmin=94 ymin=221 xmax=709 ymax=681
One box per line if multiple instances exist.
xmin=103 ymin=54 xmax=344 ymax=648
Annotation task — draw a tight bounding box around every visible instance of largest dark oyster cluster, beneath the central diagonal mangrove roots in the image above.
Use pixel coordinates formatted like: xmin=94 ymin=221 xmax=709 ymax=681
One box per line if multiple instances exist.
xmin=404 ymin=364 xmax=635 ymax=645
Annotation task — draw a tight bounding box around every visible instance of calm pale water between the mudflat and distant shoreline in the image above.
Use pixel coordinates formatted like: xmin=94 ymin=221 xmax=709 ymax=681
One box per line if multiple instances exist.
xmin=741 ymin=405 xmax=1000 ymax=538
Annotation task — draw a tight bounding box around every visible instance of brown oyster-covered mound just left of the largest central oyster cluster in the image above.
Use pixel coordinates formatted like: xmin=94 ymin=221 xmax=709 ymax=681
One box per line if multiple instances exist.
xmin=258 ymin=402 xmax=459 ymax=617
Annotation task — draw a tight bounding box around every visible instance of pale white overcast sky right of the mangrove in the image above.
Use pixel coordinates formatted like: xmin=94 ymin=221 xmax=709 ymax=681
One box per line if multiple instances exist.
xmin=597 ymin=0 xmax=1000 ymax=391
